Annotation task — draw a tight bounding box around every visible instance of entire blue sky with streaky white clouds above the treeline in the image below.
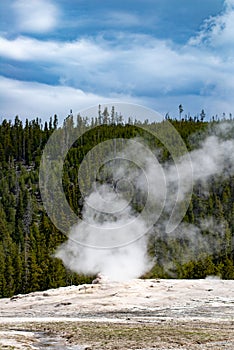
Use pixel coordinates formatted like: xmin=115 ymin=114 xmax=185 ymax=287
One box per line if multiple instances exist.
xmin=0 ymin=0 xmax=234 ymax=120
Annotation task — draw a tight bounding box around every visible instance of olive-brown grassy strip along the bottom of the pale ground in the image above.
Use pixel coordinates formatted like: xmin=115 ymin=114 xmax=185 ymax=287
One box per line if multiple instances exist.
xmin=0 ymin=320 xmax=234 ymax=350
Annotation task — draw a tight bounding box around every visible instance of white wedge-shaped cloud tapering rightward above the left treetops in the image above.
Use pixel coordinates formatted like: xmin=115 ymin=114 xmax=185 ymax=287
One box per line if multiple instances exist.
xmin=0 ymin=76 xmax=139 ymax=121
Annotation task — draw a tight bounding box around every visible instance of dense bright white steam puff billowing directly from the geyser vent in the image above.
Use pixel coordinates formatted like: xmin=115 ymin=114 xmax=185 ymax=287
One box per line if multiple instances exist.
xmin=56 ymin=186 xmax=154 ymax=280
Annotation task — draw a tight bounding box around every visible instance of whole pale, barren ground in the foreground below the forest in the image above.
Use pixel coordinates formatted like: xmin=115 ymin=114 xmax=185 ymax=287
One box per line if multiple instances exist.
xmin=0 ymin=278 xmax=234 ymax=350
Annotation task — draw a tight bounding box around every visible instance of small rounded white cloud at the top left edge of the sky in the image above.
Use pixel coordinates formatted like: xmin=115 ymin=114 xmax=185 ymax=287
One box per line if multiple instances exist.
xmin=12 ymin=0 xmax=59 ymax=33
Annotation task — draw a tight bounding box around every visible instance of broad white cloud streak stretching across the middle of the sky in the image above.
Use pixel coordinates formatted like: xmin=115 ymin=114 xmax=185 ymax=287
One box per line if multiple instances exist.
xmin=0 ymin=35 xmax=228 ymax=95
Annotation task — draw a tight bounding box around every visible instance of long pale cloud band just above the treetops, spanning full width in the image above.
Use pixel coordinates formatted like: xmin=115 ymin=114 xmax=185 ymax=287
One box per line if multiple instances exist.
xmin=0 ymin=76 xmax=234 ymax=121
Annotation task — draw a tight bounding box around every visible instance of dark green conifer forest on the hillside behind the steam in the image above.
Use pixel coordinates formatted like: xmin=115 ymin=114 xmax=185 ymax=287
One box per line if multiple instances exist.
xmin=0 ymin=111 xmax=234 ymax=297
